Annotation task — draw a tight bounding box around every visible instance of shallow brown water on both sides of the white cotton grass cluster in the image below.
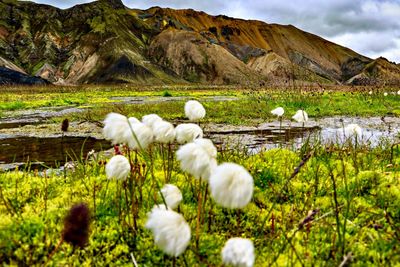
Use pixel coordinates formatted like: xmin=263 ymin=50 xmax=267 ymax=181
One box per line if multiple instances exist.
xmin=0 ymin=117 xmax=400 ymax=171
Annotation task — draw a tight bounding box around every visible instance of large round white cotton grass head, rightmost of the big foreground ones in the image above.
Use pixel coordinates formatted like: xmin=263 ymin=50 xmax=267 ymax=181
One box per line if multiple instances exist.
xmin=209 ymin=163 xmax=254 ymax=209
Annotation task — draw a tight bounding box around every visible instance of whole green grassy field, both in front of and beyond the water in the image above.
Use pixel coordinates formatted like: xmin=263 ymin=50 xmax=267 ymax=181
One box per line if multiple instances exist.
xmin=0 ymin=87 xmax=400 ymax=266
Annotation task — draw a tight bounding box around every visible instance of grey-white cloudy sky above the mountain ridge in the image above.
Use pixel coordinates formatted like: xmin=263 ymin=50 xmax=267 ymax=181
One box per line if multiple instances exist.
xmin=30 ymin=0 xmax=400 ymax=63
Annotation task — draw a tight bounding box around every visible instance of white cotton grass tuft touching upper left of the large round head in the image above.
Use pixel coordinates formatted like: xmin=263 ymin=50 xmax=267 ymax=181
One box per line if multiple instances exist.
xmin=176 ymin=143 xmax=217 ymax=181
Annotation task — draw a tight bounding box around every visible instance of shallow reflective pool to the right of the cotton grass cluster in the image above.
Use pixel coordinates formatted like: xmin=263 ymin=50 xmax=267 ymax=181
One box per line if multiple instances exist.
xmin=208 ymin=116 xmax=400 ymax=153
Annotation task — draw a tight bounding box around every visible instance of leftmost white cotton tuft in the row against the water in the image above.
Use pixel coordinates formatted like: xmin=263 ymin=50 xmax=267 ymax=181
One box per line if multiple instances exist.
xmin=103 ymin=112 xmax=128 ymax=145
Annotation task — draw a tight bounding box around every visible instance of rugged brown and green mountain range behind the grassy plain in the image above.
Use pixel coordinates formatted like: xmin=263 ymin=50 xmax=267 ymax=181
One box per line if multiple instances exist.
xmin=0 ymin=0 xmax=400 ymax=84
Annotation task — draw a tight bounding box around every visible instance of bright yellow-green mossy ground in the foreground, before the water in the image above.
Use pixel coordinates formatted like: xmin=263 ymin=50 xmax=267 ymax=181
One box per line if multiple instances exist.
xmin=0 ymin=141 xmax=400 ymax=266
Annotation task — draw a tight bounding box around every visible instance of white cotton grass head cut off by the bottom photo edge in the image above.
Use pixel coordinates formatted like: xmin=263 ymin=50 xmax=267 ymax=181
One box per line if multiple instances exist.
xmin=221 ymin=237 xmax=255 ymax=267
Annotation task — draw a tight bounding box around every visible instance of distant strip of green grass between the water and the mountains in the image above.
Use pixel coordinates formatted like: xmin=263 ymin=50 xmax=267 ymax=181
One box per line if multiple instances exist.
xmin=0 ymin=86 xmax=400 ymax=125
